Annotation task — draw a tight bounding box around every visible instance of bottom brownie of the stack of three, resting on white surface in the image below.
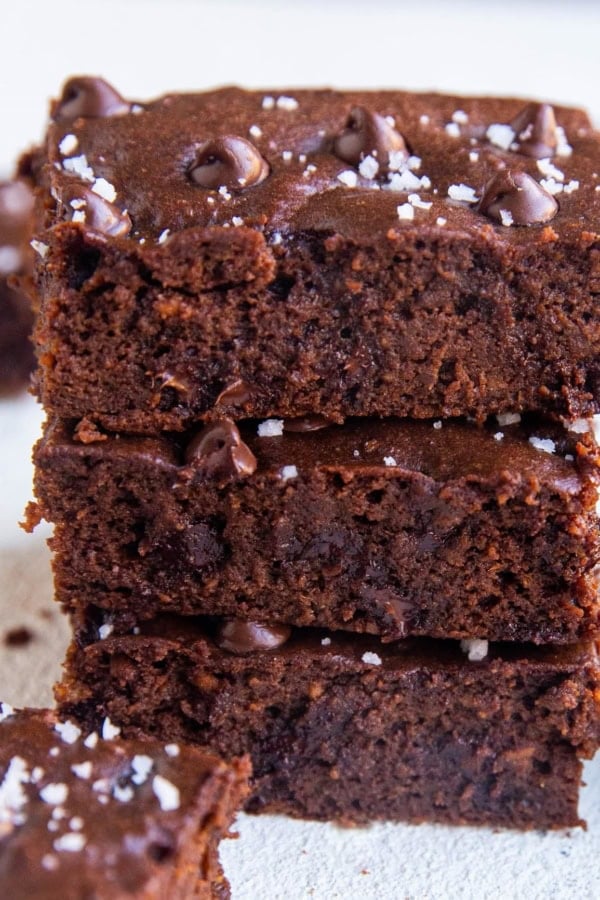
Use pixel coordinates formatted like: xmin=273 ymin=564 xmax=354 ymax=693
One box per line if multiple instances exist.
xmin=58 ymin=617 xmax=600 ymax=828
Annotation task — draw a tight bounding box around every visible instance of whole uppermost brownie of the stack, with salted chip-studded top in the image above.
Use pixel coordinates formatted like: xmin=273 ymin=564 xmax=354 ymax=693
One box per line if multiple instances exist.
xmin=27 ymin=78 xmax=600 ymax=432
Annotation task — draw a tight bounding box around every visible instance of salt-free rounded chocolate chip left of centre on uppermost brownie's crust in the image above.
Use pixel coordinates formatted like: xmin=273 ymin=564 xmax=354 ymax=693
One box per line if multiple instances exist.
xmin=188 ymin=135 xmax=269 ymax=190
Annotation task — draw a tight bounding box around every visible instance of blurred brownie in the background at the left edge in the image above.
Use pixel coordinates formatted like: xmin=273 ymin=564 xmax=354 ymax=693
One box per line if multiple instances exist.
xmin=0 ymin=181 xmax=34 ymax=395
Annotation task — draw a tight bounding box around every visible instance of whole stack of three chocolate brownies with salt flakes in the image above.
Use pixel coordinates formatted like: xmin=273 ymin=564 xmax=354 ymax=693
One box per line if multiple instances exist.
xmin=21 ymin=78 xmax=600 ymax=828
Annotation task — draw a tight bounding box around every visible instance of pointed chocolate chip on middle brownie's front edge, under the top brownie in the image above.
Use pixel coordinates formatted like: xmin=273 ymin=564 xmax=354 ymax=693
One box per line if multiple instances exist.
xmin=185 ymin=419 xmax=256 ymax=477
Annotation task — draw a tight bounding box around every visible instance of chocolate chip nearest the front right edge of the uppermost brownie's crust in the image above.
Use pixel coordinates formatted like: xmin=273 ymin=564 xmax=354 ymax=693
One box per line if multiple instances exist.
xmin=477 ymin=170 xmax=558 ymax=225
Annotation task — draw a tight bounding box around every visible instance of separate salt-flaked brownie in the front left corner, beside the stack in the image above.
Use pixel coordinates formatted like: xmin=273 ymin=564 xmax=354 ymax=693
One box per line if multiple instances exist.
xmin=0 ymin=704 xmax=249 ymax=900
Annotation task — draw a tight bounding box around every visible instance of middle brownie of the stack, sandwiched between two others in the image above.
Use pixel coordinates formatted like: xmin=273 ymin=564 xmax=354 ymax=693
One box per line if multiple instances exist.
xmin=35 ymin=420 xmax=600 ymax=643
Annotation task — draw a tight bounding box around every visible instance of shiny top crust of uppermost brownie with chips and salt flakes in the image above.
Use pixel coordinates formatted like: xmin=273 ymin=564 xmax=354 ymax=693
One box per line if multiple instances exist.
xmin=40 ymin=78 xmax=600 ymax=245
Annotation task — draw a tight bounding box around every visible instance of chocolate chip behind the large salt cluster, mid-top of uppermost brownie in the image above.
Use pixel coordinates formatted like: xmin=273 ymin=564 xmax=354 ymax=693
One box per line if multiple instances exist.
xmin=333 ymin=106 xmax=409 ymax=174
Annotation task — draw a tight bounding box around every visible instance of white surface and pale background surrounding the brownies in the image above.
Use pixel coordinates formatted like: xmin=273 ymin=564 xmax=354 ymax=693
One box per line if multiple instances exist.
xmin=0 ymin=0 xmax=600 ymax=900
